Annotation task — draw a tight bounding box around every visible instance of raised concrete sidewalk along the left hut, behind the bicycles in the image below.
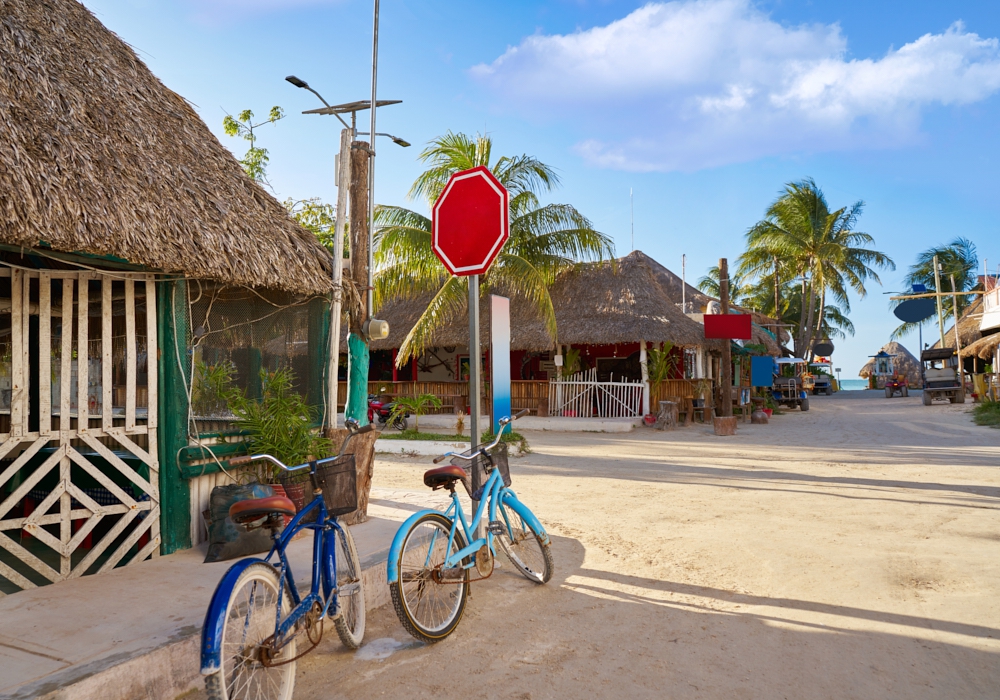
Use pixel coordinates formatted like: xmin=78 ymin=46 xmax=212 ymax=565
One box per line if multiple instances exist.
xmin=0 ymin=488 xmax=446 ymax=700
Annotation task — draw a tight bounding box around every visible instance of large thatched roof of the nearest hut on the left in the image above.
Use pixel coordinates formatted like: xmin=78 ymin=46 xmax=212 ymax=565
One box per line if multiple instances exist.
xmin=0 ymin=0 xmax=332 ymax=293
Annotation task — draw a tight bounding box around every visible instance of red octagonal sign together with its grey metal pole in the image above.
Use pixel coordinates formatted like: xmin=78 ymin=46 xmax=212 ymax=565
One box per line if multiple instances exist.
xmin=432 ymin=166 xmax=510 ymax=510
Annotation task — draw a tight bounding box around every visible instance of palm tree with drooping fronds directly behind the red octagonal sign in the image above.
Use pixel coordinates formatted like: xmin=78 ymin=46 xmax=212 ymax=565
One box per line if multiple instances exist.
xmin=375 ymin=132 xmax=614 ymax=366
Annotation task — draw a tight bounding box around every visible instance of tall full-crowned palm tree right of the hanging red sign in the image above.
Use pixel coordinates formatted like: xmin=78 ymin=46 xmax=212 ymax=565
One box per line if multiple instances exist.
xmin=737 ymin=178 xmax=896 ymax=357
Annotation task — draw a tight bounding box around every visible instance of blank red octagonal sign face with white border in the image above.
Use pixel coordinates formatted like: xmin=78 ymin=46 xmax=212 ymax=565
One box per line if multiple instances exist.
xmin=433 ymin=165 xmax=510 ymax=276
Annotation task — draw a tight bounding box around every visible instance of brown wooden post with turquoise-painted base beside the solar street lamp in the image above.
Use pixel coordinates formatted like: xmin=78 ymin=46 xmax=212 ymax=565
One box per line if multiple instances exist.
xmin=344 ymin=141 xmax=370 ymax=425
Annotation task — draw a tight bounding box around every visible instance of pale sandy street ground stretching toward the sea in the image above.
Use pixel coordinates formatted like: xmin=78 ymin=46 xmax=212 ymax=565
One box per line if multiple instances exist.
xmin=189 ymin=392 xmax=1000 ymax=700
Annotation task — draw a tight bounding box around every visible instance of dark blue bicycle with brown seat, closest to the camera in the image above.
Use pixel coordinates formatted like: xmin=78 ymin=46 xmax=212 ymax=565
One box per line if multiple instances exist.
xmin=201 ymin=421 xmax=374 ymax=700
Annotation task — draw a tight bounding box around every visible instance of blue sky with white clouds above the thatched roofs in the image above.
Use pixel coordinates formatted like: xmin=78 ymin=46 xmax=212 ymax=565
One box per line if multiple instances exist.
xmin=85 ymin=0 xmax=1000 ymax=378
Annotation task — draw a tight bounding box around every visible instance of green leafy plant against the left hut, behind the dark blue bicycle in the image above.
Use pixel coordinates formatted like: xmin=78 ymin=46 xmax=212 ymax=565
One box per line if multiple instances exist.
xmin=226 ymin=368 xmax=332 ymax=477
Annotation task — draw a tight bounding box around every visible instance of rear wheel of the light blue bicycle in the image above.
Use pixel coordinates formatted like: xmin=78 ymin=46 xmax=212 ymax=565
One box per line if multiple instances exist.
xmin=389 ymin=513 xmax=469 ymax=642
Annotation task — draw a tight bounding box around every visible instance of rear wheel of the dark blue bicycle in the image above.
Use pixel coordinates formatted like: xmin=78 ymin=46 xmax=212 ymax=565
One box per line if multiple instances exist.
xmin=205 ymin=562 xmax=296 ymax=700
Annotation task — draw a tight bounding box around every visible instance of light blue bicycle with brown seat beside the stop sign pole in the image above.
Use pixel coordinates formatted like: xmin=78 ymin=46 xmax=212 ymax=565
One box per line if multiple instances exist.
xmin=387 ymin=411 xmax=553 ymax=642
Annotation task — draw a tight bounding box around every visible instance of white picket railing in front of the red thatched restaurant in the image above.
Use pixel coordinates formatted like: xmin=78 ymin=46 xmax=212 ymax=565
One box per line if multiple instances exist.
xmin=549 ymin=368 xmax=643 ymax=418
